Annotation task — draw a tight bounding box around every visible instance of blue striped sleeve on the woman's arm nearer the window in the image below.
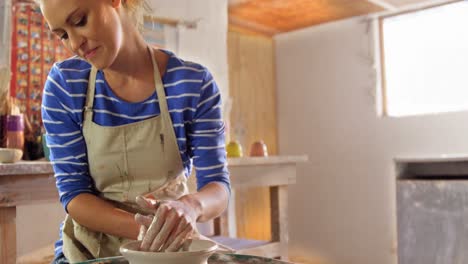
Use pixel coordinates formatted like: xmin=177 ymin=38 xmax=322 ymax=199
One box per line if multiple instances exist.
xmin=187 ymin=71 xmax=230 ymax=192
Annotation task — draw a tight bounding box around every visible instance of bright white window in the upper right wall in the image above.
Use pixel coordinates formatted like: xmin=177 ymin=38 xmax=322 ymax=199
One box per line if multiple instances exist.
xmin=380 ymin=1 xmax=468 ymax=116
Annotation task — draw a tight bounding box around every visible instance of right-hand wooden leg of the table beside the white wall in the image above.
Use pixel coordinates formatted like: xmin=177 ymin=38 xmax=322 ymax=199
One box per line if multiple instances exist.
xmin=270 ymin=185 xmax=289 ymax=260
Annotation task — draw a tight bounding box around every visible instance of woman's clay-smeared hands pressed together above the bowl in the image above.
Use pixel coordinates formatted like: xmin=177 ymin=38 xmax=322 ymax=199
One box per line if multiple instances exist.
xmin=135 ymin=196 xmax=197 ymax=251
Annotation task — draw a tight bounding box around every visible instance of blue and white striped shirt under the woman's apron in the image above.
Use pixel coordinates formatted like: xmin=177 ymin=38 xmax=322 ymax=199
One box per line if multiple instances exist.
xmin=42 ymin=51 xmax=230 ymax=255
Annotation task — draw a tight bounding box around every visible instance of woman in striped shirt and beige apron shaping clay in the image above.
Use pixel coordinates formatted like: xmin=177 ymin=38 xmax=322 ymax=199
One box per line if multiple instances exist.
xmin=39 ymin=0 xmax=230 ymax=263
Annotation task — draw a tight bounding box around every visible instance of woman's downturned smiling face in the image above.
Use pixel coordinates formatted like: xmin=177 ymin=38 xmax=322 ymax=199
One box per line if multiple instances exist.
xmin=40 ymin=0 xmax=123 ymax=69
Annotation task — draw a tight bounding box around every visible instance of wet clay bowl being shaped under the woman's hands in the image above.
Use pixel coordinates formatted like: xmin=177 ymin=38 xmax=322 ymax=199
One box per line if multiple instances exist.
xmin=120 ymin=240 xmax=218 ymax=264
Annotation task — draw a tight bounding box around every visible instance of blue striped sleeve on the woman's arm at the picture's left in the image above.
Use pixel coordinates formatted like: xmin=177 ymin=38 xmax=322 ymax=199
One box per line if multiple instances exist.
xmin=42 ymin=65 xmax=96 ymax=212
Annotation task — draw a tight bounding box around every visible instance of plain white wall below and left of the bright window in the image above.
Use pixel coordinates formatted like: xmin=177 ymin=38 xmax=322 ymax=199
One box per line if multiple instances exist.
xmin=276 ymin=18 xmax=468 ymax=264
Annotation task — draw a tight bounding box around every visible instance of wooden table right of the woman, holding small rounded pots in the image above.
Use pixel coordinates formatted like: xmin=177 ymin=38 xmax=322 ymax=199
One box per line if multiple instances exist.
xmin=213 ymin=156 xmax=308 ymax=260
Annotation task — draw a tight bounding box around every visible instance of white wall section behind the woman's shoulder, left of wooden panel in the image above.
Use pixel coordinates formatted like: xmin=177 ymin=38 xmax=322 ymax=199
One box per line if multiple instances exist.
xmin=148 ymin=0 xmax=229 ymax=98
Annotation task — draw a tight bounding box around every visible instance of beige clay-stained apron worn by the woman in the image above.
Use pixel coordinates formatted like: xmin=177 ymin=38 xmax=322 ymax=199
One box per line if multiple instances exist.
xmin=62 ymin=48 xmax=188 ymax=263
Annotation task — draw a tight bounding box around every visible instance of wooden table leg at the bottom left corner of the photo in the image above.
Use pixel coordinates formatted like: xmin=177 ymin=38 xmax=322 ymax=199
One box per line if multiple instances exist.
xmin=0 ymin=207 xmax=16 ymax=264
